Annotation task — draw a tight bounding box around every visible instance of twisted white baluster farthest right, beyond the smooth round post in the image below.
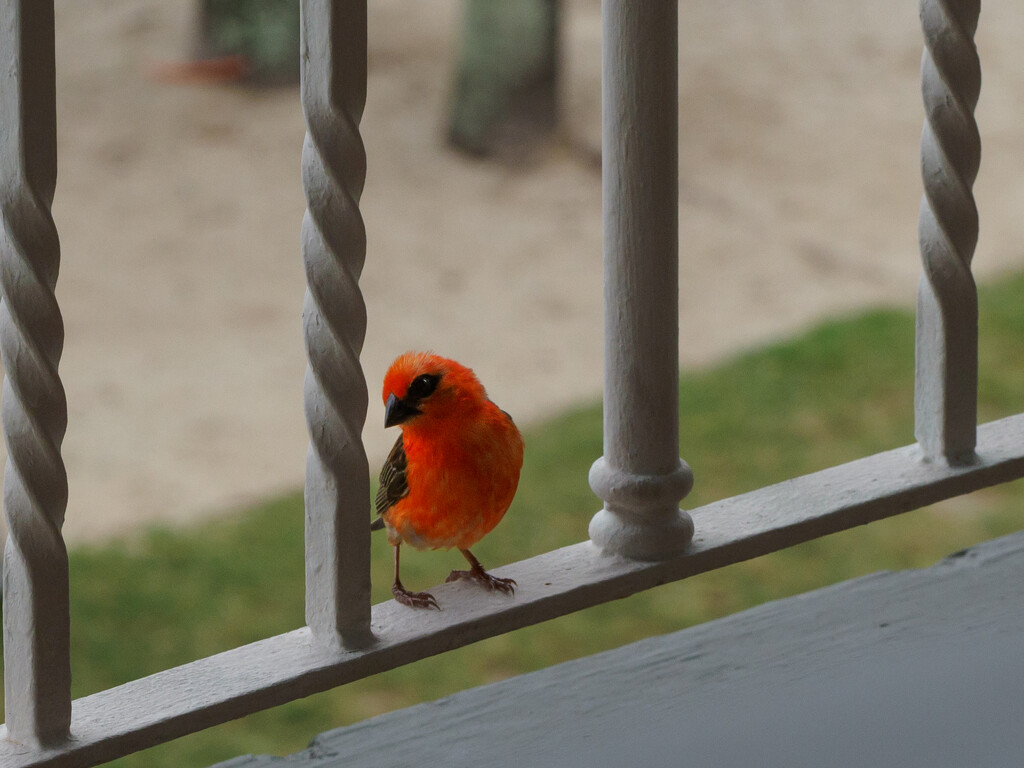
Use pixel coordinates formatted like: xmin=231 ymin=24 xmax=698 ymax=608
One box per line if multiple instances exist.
xmin=914 ymin=0 xmax=981 ymax=463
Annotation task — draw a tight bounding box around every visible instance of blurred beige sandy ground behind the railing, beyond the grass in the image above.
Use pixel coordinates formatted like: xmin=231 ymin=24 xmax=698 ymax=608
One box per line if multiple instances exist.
xmin=2 ymin=0 xmax=1024 ymax=542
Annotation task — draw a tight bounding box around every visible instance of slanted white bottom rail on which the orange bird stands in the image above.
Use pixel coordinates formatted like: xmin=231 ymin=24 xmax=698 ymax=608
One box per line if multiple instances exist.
xmin=0 ymin=415 xmax=1024 ymax=768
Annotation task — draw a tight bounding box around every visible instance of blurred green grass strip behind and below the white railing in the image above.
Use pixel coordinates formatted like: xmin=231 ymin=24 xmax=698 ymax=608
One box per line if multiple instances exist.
xmin=2 ymin=276 xmax=1024 ymax=768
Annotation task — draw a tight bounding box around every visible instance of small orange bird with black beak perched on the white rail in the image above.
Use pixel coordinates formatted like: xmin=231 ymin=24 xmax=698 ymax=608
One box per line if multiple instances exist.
xmin=370 ymin=352 xmax=523 ymax=608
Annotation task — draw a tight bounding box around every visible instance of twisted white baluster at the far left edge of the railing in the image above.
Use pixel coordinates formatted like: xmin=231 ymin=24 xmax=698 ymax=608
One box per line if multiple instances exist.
xmin=0 ymin=0 xmax=71 ymax=744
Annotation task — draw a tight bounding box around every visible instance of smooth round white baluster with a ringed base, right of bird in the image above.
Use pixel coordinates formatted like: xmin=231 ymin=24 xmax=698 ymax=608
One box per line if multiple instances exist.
xmin=590 ymin=0 xmax=693 ymax=559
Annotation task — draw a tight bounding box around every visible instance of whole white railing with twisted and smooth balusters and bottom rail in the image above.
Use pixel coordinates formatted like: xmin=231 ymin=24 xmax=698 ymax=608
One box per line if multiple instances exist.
xmin=0 ymin=0 xmax=1024 ymax=768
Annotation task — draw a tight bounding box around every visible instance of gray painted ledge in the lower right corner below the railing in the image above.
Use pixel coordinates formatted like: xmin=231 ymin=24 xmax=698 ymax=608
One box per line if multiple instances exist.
xmin=215 ymin=532 xmax=1024 ymax=768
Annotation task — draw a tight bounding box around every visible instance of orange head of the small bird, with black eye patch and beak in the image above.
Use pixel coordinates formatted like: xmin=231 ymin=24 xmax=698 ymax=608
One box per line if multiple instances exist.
xmin=382 ymin=352 xmax=487 ymax=427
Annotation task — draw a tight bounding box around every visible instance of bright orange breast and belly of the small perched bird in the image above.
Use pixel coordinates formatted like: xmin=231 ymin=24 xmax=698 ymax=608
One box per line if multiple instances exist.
xmin=385 ymin=402 xmax=523 ymax=549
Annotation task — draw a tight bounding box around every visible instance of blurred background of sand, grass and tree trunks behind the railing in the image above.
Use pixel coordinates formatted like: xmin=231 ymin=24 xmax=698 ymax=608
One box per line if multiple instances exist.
xmin=2 ymin=0 xmax=1024 ymax=765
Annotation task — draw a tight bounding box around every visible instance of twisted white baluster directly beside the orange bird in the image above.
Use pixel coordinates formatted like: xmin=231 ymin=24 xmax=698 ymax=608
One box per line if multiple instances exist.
xmin=302 ymin=0 xmax=370 ymax=647
